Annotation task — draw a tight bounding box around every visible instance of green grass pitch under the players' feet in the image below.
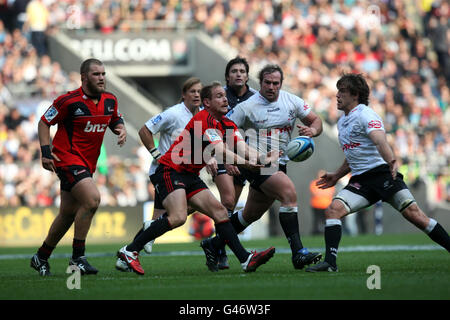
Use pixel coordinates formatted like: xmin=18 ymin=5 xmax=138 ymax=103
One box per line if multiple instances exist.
xmin=0 ymin=233 xmax=450 ymax=301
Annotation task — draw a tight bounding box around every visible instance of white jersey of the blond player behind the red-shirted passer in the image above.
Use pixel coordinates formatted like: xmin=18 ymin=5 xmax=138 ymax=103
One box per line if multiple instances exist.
xmin=145 ymin=102 xmax=193 ymax=176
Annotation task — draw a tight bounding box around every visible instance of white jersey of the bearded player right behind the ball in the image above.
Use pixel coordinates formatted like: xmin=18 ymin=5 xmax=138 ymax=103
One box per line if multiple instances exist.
xmin=227 ymin=90 xmax=311 ymax=164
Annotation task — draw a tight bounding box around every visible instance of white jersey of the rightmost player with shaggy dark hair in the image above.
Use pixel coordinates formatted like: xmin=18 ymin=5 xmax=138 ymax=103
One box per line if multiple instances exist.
xmin=338 ymin=104 xmax=386 ymax=175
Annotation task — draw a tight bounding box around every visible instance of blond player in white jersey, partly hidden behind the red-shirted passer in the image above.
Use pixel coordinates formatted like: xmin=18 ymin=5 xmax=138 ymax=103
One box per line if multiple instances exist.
xmin=116 ymin=77 xmax=202 ymax=271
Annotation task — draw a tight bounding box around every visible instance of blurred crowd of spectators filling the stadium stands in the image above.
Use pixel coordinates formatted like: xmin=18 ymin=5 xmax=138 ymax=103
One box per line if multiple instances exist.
xmin=0 ymin=0 xmax=450 ymax=206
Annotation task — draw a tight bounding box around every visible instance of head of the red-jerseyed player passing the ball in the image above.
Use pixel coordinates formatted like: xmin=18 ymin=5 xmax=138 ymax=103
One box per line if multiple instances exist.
xmin=200 ymin=81 xmax=228 ymax=119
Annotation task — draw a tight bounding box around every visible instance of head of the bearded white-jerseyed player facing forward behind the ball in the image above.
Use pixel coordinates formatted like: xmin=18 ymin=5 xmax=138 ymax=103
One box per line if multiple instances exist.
xmin=259 ymin=64 xmax=283 ymax=102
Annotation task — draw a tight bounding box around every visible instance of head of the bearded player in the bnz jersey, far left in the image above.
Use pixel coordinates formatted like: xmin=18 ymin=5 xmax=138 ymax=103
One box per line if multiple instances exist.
xmin=80 ymin=58 xmax=106 ymax=96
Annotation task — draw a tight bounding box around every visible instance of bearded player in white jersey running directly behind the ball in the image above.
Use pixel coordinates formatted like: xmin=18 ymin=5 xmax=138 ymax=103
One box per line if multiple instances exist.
xmin=203 ymin=65 xmax=322 ymax=269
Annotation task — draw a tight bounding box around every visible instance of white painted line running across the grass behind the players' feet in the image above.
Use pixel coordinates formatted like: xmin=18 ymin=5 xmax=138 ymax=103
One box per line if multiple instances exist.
xmin=0 ymin=245 xmax=444 ymax=260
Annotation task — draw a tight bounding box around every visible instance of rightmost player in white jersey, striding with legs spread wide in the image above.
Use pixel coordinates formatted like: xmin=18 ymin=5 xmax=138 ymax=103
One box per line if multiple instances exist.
xmin=306 ymin=74 xmax=450 ymax=272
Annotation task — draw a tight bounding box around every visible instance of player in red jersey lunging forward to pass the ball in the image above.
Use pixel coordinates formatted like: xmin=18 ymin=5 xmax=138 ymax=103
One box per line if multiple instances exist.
xmin=117 ymin=82 xmax=278 ymax=275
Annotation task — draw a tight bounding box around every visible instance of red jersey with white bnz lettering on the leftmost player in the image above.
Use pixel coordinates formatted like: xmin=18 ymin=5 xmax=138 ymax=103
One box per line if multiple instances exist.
xmin=41 ymin=87 xmax=123 ymax=173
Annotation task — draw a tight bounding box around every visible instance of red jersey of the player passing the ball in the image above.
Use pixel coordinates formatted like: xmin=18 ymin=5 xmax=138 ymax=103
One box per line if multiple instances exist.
xmin=159 ymin=110 xmax=242 ymax=174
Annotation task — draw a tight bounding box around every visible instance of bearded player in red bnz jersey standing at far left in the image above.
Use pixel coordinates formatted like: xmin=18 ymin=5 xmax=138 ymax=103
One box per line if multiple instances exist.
xmin=31 ymin=59 xmax=127 ymax=276
